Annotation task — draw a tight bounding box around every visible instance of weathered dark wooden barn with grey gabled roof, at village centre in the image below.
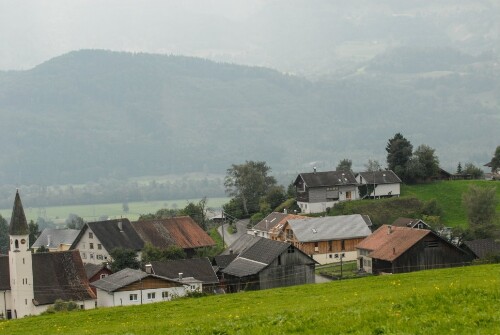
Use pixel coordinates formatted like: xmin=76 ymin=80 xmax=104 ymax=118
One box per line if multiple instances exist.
xmin=221 ymin=234 xmax=316 ymax=292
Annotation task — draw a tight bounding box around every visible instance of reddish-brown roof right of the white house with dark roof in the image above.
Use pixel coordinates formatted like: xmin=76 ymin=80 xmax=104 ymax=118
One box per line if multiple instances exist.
xmin=132 ymin=216 xmax=215 ymax=249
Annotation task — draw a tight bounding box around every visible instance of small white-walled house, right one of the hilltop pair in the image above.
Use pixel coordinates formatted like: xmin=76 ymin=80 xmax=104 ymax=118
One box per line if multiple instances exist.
xmin=356 ymin=170 xmax=402 ymax=198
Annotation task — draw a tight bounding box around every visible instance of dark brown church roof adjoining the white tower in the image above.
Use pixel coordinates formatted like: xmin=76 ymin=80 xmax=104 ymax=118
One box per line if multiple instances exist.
xmin=32 ymin=250 xmax=96 ymax=305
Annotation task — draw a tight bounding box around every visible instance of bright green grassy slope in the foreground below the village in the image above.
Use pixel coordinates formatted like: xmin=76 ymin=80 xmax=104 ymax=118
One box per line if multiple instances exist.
xmin=0 ymin=264 xmax=500 ymax=335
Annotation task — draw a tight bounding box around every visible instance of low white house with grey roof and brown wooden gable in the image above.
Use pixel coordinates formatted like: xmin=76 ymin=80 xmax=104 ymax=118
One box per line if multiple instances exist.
xmin=92 ymin=268 xmax=190 ymax=307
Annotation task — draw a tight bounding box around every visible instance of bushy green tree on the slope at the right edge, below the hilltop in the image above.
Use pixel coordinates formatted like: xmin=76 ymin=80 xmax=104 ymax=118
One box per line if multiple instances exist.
xmin=462 ymin=185 xmax=498 ymax=238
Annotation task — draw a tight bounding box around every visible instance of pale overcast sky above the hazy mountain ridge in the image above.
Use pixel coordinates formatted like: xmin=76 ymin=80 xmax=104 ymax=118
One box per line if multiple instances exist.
xmin=0 ymin=0 xmax=500 ymax=74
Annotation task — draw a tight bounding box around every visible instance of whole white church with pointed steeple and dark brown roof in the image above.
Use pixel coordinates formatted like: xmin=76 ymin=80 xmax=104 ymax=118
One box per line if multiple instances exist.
xmin=0 ymin=192 xmax=96 ymax=319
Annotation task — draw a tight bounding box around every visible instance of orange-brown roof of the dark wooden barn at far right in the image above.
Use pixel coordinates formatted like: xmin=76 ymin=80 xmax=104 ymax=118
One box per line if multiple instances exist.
xmin=356 ymin=225 xmax=432 ymax=262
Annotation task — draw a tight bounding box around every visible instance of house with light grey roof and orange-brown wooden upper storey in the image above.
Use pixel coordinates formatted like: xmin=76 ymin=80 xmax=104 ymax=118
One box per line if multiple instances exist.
xmin=273 ymin=214 xmax=372 ymax=264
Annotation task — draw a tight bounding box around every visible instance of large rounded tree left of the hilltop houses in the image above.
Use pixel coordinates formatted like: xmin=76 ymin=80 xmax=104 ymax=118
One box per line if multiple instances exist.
xmin=224 ymin=161 xmax=276 ymax=216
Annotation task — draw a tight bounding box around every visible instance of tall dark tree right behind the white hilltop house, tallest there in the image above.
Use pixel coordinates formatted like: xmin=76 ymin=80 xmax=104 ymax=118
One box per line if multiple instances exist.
xmin=385 ymin=133 xmax=413 ymax=181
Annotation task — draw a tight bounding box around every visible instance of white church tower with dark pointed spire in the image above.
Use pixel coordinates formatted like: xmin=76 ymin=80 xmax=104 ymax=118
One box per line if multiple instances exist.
xmin=9 ymin=191 xmax=34 ymax=318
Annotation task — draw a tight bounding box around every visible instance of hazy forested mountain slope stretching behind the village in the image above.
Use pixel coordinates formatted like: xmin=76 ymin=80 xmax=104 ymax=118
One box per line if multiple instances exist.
xmin=0 ymin=49 xmax=500 ymax=184
